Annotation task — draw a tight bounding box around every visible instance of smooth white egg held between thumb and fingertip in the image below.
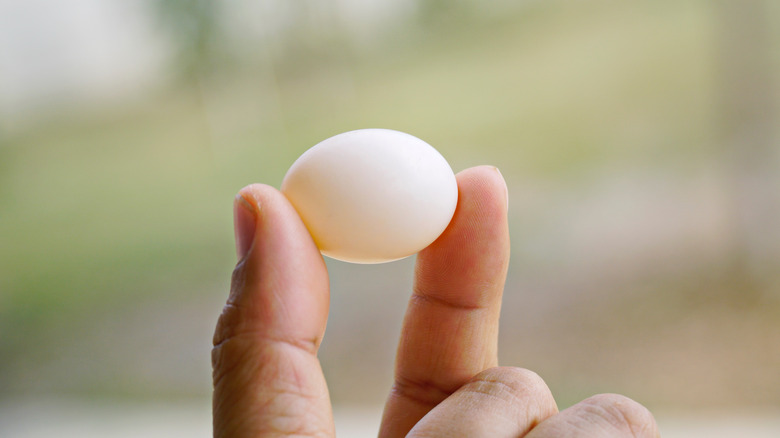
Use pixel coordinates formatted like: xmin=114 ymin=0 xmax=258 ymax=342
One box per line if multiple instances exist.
xmin=281 ymin=129 xmax=458 ymax=263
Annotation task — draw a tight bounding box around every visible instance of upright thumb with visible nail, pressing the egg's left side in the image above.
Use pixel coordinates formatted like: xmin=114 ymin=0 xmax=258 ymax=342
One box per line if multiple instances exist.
xmin=211 ymin=184 xmax=335 ymax=438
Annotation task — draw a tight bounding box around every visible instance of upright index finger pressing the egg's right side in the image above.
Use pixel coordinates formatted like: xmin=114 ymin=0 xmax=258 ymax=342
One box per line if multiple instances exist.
xmin=379 ymin=166 xmax=509 ymax=437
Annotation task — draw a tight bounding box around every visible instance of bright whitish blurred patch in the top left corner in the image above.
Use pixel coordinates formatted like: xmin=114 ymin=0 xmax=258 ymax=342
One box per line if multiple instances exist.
xmin=0 ymin=0 xmax=168 ymax=129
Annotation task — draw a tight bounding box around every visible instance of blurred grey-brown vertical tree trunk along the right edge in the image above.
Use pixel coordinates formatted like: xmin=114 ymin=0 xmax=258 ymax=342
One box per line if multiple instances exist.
xmin=717 ymin=0 xmax=780 ymax=303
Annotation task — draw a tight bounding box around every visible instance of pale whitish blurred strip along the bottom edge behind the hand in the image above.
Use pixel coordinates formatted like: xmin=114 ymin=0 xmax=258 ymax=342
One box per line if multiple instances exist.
xmin=0 ymin=400 xmax=780 ymax=438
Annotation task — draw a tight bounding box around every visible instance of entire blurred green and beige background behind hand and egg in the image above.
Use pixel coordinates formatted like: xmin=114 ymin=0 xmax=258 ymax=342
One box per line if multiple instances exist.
xmin=0 ymin=0 xmax=780 ymax=437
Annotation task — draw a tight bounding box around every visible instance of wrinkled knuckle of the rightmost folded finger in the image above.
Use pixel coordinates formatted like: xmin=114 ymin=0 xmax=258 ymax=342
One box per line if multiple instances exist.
xmin=585 ymin=394 xmax=658 ymax=438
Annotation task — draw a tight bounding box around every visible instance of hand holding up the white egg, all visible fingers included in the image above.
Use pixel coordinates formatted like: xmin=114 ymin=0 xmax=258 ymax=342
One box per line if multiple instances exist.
xmin=212 ymin=166 xmax=659 ymax=438
